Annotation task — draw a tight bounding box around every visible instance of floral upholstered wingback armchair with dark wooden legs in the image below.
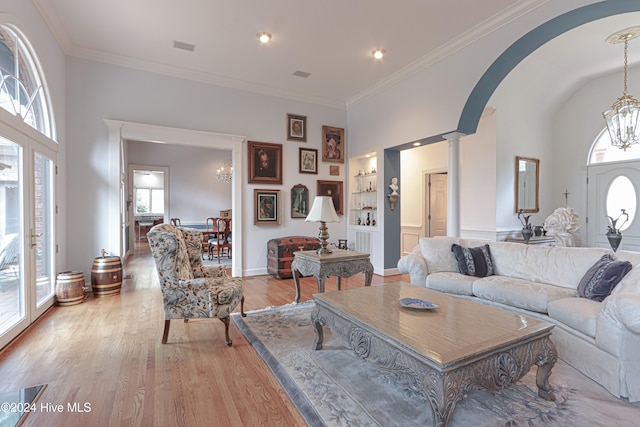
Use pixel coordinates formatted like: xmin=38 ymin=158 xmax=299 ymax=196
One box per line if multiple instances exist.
xmin=147 ymin=224 xmax=245 ymax=346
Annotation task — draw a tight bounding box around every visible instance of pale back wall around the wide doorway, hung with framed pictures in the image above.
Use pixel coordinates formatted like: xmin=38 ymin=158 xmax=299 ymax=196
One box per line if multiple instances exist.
xmin=67 ymin=58 xmax=349 ymax=275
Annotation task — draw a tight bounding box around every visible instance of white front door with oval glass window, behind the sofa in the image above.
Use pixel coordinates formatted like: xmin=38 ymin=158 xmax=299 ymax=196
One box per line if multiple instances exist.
xmin=587 ymin=161 xmax=640 ymax=251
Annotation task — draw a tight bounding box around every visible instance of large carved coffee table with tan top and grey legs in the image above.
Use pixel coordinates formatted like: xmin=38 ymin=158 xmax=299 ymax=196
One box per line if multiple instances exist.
xmin=311 ymin=282 xmax=557 ymax=426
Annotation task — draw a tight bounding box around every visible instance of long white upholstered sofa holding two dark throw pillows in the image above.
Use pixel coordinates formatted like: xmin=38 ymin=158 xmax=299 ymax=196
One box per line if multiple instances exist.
xmin=398 ymin=237 xmax=640 ymax=402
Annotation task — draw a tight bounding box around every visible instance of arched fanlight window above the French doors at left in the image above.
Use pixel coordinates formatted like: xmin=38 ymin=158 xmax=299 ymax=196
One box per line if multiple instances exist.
xmin=0 ymin=25 xmax=55 ymax=140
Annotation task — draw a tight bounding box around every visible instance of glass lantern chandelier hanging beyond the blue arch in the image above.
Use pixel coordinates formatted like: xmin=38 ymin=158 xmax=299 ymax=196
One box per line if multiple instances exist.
xmin=602 ymin=26 xmax=640 ymax=151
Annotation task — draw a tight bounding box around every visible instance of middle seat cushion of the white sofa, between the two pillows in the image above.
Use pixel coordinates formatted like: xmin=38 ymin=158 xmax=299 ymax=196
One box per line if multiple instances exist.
xmin=473 ymin=276 xmax=577 ymax=313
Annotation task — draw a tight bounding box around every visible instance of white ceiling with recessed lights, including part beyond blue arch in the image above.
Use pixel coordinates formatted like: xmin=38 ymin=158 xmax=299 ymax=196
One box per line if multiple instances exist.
xmin=33 ymin=0 xmax=640 ymax=107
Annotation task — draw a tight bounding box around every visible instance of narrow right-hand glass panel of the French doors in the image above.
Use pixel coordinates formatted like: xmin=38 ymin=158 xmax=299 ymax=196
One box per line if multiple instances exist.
xmin=31 ymin=153 xmax=55 ymax=307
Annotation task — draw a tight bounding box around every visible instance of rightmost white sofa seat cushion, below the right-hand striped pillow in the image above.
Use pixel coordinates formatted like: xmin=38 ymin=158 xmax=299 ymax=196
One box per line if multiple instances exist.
xmin=547 ymin=298 xmax=601 ymax=338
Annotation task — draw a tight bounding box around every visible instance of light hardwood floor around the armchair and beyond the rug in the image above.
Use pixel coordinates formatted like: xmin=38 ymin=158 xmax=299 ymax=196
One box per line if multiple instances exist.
xmin=0 ymin=243 xmax=409 ymax=426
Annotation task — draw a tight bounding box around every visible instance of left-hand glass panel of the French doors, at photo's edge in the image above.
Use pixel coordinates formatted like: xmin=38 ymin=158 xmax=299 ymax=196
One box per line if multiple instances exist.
xmin=0 ymin=137 xmax=25 ymax=335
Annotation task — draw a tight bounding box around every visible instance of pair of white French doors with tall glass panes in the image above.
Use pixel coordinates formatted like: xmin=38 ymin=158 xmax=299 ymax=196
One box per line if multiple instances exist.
xmin=0 ymin=126 xmax=56 ymax=347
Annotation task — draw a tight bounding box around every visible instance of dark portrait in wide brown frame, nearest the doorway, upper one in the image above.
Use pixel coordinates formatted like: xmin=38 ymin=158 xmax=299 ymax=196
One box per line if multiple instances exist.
xmin=248 ymin=141 xmax=282 ymax=184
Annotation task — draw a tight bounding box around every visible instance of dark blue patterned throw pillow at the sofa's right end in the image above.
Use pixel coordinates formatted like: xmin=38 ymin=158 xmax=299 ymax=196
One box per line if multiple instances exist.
xmin=578 ymin=254 xmax=632 ymax=301
